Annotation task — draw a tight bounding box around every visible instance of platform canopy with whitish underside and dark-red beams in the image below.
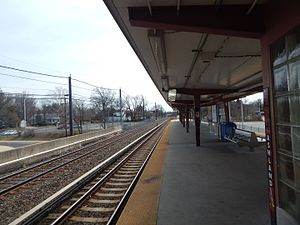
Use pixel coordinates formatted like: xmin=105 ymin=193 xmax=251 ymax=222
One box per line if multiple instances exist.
xmin=104 ymin=0 xmax=267 ymax=106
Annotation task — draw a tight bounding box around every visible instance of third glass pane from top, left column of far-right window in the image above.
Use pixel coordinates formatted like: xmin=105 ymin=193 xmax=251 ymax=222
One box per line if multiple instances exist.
xmin=276 ymin=96 xmax=290 ymax=123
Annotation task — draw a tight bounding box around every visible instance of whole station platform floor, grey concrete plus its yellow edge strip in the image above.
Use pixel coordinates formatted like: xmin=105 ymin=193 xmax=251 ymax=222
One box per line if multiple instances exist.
xmin=117 ymin=120 xmax=270 ymax=225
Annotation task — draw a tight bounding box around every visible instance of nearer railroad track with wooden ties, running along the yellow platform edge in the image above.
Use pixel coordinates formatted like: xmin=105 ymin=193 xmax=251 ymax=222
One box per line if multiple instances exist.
xmin=12 ymin=120 xmax=166 ymax=225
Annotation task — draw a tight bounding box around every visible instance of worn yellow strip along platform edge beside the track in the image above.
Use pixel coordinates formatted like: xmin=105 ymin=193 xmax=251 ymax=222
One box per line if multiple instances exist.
xmin=117 ymin=122 xmax=172 ymax=225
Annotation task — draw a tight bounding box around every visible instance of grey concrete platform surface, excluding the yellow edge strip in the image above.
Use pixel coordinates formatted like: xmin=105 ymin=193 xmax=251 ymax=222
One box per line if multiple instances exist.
xmin=157 ymin=122 xmax=270 ymax=225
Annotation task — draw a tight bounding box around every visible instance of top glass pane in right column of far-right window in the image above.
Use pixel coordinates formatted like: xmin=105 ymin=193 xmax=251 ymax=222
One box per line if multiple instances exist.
xmin=287 ymin=26 xmax=300 ymax=59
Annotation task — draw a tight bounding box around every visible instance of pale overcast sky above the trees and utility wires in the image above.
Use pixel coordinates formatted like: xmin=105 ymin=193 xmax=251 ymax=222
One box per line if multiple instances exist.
xmin=0 ymin=0 xmax=262 ymax=110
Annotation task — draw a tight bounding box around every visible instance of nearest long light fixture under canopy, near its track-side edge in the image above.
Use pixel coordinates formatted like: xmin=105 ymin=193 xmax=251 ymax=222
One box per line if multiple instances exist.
xmin=148 ymin=29 xmax=167 ymax=74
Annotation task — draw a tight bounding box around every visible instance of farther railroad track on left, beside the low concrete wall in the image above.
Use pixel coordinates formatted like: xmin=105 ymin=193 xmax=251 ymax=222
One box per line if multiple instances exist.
xmin=0 ymin=124 xmax=150 ymax=196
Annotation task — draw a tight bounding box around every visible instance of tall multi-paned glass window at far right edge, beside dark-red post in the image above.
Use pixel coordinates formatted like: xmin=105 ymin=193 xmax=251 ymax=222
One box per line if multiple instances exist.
xmin=271 ymin=23 xmax=300 ymax=222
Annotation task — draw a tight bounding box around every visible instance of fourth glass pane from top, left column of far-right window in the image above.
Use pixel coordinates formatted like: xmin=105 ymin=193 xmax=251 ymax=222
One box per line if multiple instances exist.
xmin=277 ymin=126 xmax=293 ymax=155
